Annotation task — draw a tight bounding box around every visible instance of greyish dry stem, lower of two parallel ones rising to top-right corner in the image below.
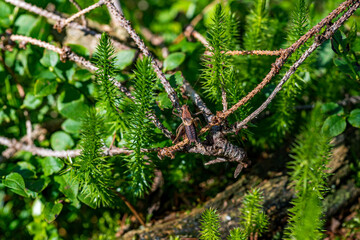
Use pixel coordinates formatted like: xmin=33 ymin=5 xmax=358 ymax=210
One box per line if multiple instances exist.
xmin=226 ymin=1 xmax=360 ymax=132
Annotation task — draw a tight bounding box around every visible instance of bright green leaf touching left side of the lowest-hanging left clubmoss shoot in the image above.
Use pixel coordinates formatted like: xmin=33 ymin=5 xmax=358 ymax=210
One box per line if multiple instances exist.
xmin=54 ymin=172 xmax=79 ymax=202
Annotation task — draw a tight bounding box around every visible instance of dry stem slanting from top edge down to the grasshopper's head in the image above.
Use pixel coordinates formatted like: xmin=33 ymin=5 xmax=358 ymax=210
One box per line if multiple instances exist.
xmin=104 ymin=0 xmax=181 ymax=113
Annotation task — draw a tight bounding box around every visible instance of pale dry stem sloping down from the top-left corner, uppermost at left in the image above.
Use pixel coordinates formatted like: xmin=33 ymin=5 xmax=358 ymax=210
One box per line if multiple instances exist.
xmin=5 ymin=0 xmax=130 ymax=49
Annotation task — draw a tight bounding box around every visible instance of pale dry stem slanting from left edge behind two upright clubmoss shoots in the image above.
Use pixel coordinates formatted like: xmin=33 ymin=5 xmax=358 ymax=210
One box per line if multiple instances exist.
xmin=6 ymin=35 xmax=173 ymax=139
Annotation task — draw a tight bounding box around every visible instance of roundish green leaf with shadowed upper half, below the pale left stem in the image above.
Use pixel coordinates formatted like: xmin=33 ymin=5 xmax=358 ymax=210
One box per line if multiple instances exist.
xmin=57 ymin=87 xmax=88 ymax=121
